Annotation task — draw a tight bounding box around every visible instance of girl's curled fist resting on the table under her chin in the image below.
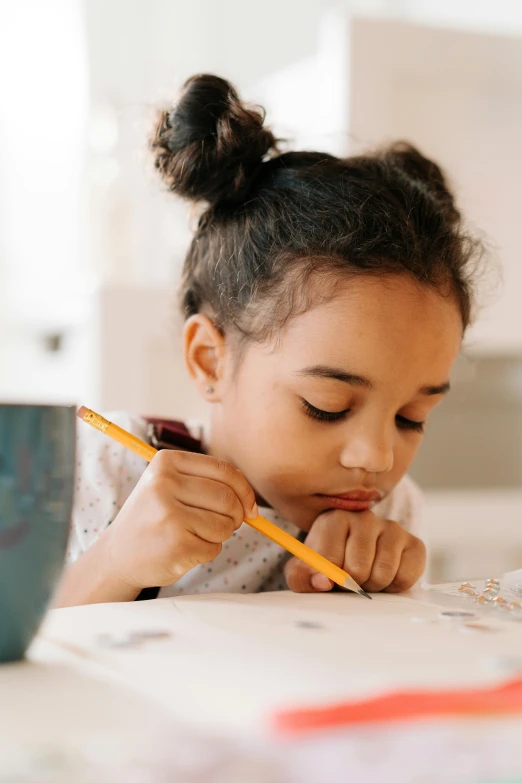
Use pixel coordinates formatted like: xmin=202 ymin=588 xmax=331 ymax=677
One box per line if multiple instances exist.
xmin=285 ymin=510 xmax=426 ymax=593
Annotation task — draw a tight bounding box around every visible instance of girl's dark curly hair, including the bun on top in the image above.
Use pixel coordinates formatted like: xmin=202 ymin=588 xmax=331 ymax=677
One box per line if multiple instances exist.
xmin=151 ymin=75 xmax=482 ymax=340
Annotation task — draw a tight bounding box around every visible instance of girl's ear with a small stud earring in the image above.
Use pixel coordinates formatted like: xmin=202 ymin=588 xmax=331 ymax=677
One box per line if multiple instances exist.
xmin=183 ymin=313 xmax=226 ymax=402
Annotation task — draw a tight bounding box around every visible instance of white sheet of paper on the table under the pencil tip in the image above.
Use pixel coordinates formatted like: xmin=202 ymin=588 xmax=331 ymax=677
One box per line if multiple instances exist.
xmin=33 ymin=592 xmax=522 ymax=732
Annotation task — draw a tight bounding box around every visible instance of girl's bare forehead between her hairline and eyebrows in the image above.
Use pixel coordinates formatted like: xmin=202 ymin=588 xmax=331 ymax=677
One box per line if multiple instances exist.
xmin=262 ymin=276 xmax=462 ymax=374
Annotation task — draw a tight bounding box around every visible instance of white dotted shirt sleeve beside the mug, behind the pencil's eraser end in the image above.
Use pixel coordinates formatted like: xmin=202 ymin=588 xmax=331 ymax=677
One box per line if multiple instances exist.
xmin=67 ymin=412 xmax=147 ymax=563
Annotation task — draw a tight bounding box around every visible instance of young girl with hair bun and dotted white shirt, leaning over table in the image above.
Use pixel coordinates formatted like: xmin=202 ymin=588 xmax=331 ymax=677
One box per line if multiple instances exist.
xmin=53 ymin=76 xmax=478 ymax=605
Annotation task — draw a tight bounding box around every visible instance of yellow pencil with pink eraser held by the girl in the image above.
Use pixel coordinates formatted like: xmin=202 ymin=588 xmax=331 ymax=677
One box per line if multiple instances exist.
xmin=78 ymin=405 xmax=371 ymax=598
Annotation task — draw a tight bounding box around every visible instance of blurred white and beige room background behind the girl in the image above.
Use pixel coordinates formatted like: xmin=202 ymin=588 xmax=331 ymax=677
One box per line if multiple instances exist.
xmin=0 ymin=0 xmax=522 ymax=580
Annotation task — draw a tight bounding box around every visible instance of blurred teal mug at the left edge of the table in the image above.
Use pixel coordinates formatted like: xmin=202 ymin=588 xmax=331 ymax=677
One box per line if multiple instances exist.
xmin=0 ymin=404 xmax=76 ymax=662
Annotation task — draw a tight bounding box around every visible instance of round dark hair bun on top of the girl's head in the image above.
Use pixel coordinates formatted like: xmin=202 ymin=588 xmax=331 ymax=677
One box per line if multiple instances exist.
xmin=151 ymin=74 xmax=276 ymax=204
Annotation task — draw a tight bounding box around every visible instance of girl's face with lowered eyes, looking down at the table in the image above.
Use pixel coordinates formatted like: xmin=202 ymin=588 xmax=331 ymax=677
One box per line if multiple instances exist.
xmin=203 ymin=277 xmax=462 ymax=530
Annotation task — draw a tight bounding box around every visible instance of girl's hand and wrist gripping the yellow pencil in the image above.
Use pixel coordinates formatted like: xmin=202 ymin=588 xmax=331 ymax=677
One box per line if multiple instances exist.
xmin=98 ymin=450 xmax=257 ymax=591
